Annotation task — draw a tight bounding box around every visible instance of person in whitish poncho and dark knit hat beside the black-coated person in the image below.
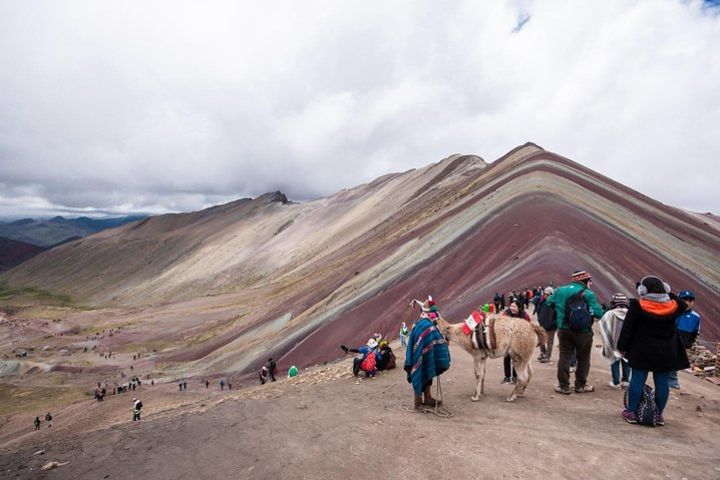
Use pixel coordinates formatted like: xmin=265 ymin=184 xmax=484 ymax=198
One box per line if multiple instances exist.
xmin=600 ymin=293 xmax=630 ymax=389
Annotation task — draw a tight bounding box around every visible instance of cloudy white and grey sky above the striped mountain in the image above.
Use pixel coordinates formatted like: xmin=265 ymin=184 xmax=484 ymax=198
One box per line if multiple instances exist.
xmin=0 ymin=0 xmax=720 ymax=219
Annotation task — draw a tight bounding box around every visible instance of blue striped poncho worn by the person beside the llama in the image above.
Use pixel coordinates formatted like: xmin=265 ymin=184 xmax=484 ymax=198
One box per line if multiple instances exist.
xmin=403 ymin=318 xmax=450 ymax=395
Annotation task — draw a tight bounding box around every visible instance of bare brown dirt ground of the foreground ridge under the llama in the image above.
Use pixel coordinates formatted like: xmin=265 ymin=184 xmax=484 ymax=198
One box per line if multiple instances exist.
xmin=0 ymin=337 xmax=720 ymax=480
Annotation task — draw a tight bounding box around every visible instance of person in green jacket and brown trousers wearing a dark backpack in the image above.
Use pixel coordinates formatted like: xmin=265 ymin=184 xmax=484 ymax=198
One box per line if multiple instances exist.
xmin=547 ymin=270 xmax=605 ymax=395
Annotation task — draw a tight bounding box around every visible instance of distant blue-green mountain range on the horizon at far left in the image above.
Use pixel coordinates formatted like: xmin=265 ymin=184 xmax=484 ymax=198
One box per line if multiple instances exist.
xmin=0 ymin=216 xmax=146 ymax=247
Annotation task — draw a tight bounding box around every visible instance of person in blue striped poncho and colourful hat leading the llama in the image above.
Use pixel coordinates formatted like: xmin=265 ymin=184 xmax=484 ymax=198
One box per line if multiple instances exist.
xmin=403 ymin=297 xmax=450 ymax=410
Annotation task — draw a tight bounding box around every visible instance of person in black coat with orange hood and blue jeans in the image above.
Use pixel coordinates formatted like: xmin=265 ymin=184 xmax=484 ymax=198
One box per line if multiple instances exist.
xmin=618 ymin=276 xmax=690 ymax=425
